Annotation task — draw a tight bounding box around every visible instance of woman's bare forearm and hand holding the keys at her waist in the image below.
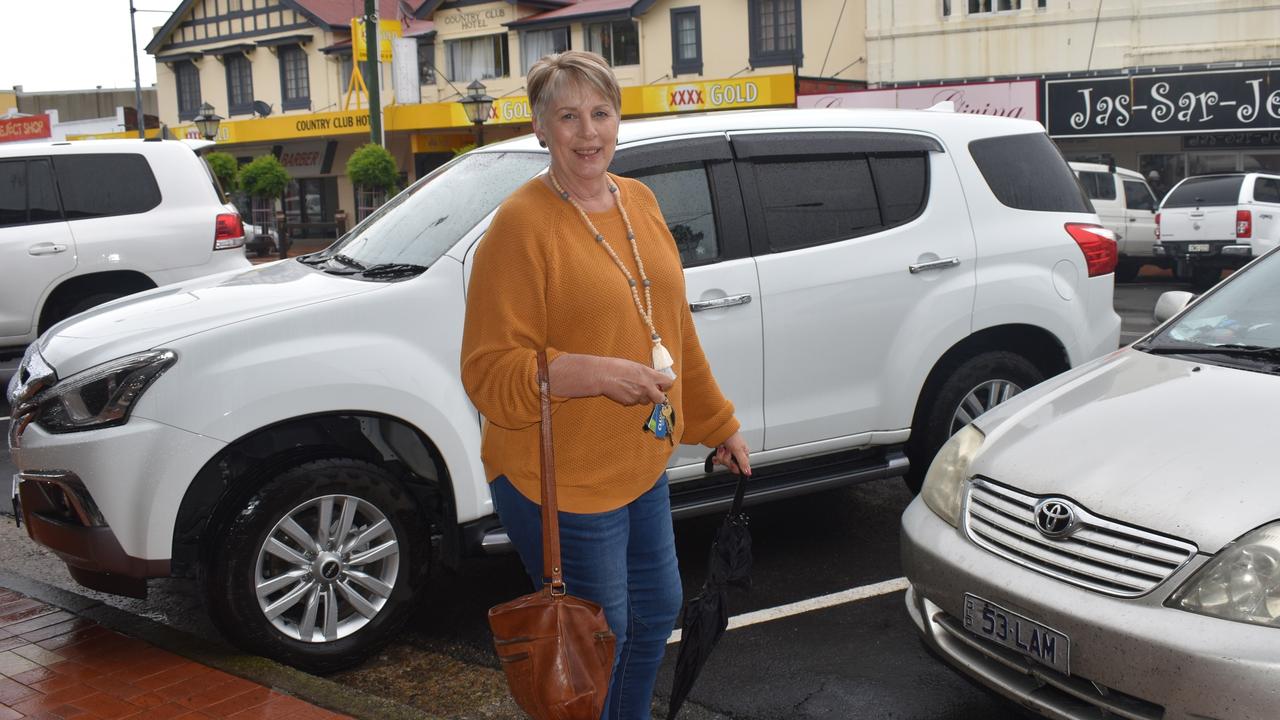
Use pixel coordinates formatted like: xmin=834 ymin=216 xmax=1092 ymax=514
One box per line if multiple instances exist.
xmin=548 ymin=355 xmax=675 ymax=405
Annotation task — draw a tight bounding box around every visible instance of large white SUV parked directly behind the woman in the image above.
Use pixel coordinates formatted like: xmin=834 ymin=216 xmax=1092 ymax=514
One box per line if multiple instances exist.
xmin=9 ymin=110 xmax=1120 ymax=670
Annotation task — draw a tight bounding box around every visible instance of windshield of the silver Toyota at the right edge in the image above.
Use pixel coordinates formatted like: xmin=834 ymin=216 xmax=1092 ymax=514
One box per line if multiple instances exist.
xmin=1139 ymin=252 xmax=1280 ymax=370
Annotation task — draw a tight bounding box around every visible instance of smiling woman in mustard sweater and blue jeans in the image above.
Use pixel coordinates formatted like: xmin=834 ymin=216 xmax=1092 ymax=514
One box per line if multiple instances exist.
xmin=462 ymin=51 xmax=750 ymax=720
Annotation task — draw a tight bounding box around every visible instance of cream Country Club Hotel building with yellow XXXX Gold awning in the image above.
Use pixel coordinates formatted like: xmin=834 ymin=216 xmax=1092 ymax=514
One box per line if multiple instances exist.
xmin=132 ymin=0 xmax=867 ymax=237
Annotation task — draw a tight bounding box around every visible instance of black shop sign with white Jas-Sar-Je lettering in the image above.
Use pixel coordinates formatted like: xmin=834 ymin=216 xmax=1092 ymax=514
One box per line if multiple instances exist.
xmin=1044 ymin=69 xmax=1280 ymax=137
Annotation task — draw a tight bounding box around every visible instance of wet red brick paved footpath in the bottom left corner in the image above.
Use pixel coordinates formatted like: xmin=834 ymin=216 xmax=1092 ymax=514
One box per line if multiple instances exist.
xmin=0 ymin=588 xmax=347 ymax=720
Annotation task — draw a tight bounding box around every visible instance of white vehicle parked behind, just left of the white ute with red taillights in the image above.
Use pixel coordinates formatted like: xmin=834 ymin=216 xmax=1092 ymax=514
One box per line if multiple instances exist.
xmin=1070 ymin=163 xmax=1172 ymax=282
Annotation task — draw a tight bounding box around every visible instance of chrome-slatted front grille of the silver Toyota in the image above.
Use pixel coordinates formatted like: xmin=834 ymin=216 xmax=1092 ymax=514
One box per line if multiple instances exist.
xmin=964 ymin=478 xmax=1197 ymax=597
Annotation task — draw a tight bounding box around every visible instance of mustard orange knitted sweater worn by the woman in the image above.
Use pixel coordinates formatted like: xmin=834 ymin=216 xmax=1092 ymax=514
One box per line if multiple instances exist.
xmin=462 ymin=176 xmax=739 ymax=512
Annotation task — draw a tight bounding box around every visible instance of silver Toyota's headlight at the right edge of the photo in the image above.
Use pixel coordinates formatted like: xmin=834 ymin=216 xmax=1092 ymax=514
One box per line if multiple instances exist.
xmin=1167 ymin=523 xmax=1280 ymax=626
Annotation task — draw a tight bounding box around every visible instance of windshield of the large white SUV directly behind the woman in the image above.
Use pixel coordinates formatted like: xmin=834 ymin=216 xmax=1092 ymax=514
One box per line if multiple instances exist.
xmin=313 ymin=152 xmax=549 ymax=277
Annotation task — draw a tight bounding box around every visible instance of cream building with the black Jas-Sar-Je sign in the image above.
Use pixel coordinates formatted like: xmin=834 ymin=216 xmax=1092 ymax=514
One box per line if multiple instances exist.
xmin=855 ymin=0 xmax=1280 ymax=192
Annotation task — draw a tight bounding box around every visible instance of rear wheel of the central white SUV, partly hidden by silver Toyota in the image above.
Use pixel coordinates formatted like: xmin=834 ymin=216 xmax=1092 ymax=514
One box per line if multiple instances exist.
xmin=902 ymin=350 xmax=1044 ymax=492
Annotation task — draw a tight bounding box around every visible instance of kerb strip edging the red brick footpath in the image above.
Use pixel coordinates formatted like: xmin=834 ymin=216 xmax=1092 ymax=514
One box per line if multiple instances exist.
xmin=0 ymin=563 xmax=443 ymax=720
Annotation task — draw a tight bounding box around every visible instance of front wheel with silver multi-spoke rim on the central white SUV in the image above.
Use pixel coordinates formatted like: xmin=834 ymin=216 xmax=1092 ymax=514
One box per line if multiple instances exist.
xmin=201 ymin=457 xmax=428 ymax=673
